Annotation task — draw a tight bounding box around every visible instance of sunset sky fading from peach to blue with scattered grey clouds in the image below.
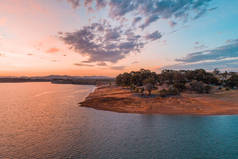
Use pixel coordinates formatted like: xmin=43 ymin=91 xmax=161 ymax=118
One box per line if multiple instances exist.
xmin=0 ymin=0 xmax=238 ymax=76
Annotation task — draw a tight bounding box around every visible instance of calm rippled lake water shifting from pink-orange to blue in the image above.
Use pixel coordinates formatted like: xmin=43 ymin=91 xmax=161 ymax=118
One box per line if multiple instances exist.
xmin=0 ymin=83 xmax=238 ymax=159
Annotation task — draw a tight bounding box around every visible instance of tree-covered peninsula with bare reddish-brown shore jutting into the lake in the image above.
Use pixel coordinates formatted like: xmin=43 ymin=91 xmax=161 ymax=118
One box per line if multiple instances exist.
xmin=80 ymin=70 xmax=238 ymax=115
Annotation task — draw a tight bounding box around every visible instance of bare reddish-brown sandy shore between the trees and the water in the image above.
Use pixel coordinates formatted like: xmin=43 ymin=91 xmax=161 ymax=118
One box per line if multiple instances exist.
xmin=80 ymin=87 xmax=238 ymax=115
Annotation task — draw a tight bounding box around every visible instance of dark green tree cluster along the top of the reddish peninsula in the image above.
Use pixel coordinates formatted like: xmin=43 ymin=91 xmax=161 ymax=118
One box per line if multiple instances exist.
xmin=116 ymin=69 xmax=238 ymax=95
